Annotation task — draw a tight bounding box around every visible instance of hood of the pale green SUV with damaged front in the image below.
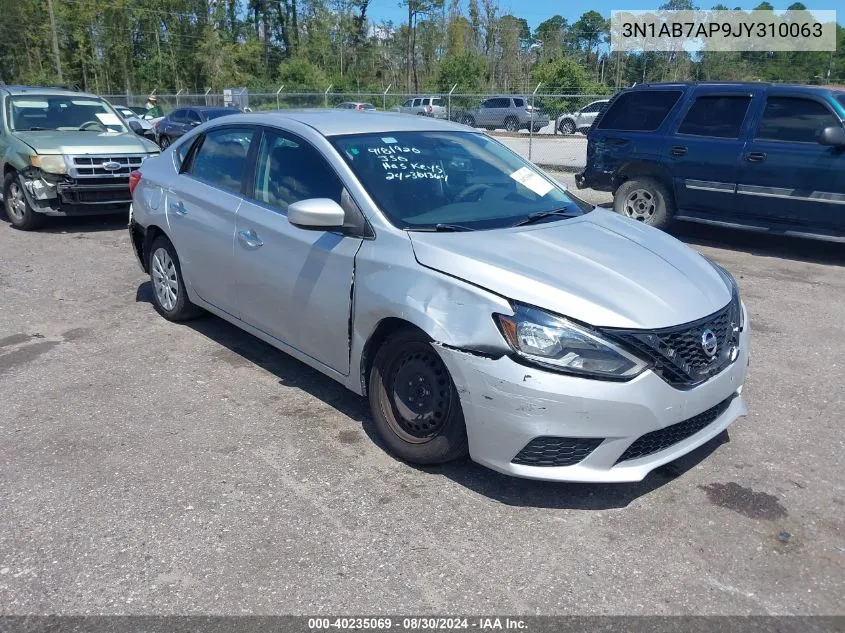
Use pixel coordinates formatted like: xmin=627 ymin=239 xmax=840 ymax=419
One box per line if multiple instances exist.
xmin=14 ymin=130 xmax=158 ymax=154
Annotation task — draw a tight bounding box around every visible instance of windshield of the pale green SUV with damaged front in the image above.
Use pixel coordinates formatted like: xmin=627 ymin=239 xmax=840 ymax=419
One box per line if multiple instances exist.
xmin=8 ymin=94 xmax=127 ymax=132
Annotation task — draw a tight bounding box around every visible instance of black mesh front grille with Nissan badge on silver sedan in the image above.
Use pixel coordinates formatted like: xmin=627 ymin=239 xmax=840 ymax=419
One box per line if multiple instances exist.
xmin=607 ymin=296 xmax=741 ymax=388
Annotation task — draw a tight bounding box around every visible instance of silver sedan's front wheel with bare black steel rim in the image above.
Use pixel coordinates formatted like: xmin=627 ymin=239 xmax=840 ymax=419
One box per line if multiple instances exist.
xmin=368 ymin=328 xmax=468 ymax=464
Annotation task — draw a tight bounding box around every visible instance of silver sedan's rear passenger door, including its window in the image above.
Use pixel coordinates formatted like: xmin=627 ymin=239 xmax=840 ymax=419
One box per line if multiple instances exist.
xmin=167 ymin=126 xmax=256 ymax=316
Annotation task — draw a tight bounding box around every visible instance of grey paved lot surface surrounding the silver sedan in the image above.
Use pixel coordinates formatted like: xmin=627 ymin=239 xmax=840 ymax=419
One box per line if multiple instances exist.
xmin=0 ymin=192 xmax=845 ymax=614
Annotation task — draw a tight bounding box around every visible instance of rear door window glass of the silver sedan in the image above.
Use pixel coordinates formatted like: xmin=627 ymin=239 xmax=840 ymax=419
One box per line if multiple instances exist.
xmin=190 ymin=127 xmax=255 ymax=193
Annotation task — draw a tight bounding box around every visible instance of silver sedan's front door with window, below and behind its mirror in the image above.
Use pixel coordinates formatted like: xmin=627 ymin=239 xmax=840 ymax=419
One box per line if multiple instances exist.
xmin=235 ymin=130 xmax=361 ymax=374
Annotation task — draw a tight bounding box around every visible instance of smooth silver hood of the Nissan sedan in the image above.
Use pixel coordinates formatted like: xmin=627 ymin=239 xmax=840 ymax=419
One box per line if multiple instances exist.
xmin=408 ymin=209 xmax=731 ymax=329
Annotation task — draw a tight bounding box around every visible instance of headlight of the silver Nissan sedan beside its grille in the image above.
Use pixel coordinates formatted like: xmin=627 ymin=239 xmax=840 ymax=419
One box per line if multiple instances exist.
xmin=494 ymin=304 xmax=647 ymax=380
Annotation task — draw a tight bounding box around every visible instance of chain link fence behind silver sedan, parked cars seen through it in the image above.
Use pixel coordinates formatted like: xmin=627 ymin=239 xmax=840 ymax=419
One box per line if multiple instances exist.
xmin=103 ymin=89 xmax=611 ymax=171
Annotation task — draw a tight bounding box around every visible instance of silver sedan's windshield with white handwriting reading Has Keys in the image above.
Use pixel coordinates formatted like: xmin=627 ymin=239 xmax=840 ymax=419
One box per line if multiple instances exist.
xmin=331 ymin=132 xmax=591 ymax=230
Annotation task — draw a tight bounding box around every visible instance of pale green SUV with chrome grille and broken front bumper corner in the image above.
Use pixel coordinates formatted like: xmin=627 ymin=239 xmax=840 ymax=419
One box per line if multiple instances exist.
xmin=0 ymin=86 xmax=159 ymax=230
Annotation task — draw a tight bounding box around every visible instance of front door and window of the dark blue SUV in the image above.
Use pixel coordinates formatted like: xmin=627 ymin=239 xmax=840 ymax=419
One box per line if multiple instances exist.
xmin=737 ymin=91 xmax=845 ymax=231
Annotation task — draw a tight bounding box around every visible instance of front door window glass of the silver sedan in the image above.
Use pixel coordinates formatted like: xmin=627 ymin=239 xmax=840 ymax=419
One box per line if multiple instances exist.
xmin=255 ymin=132 xmax=343 ymax=213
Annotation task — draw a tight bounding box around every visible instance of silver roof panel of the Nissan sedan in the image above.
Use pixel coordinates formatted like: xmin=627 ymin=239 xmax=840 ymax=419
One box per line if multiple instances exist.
xmin=227 ymin=108 xmax=474 ymax=136
